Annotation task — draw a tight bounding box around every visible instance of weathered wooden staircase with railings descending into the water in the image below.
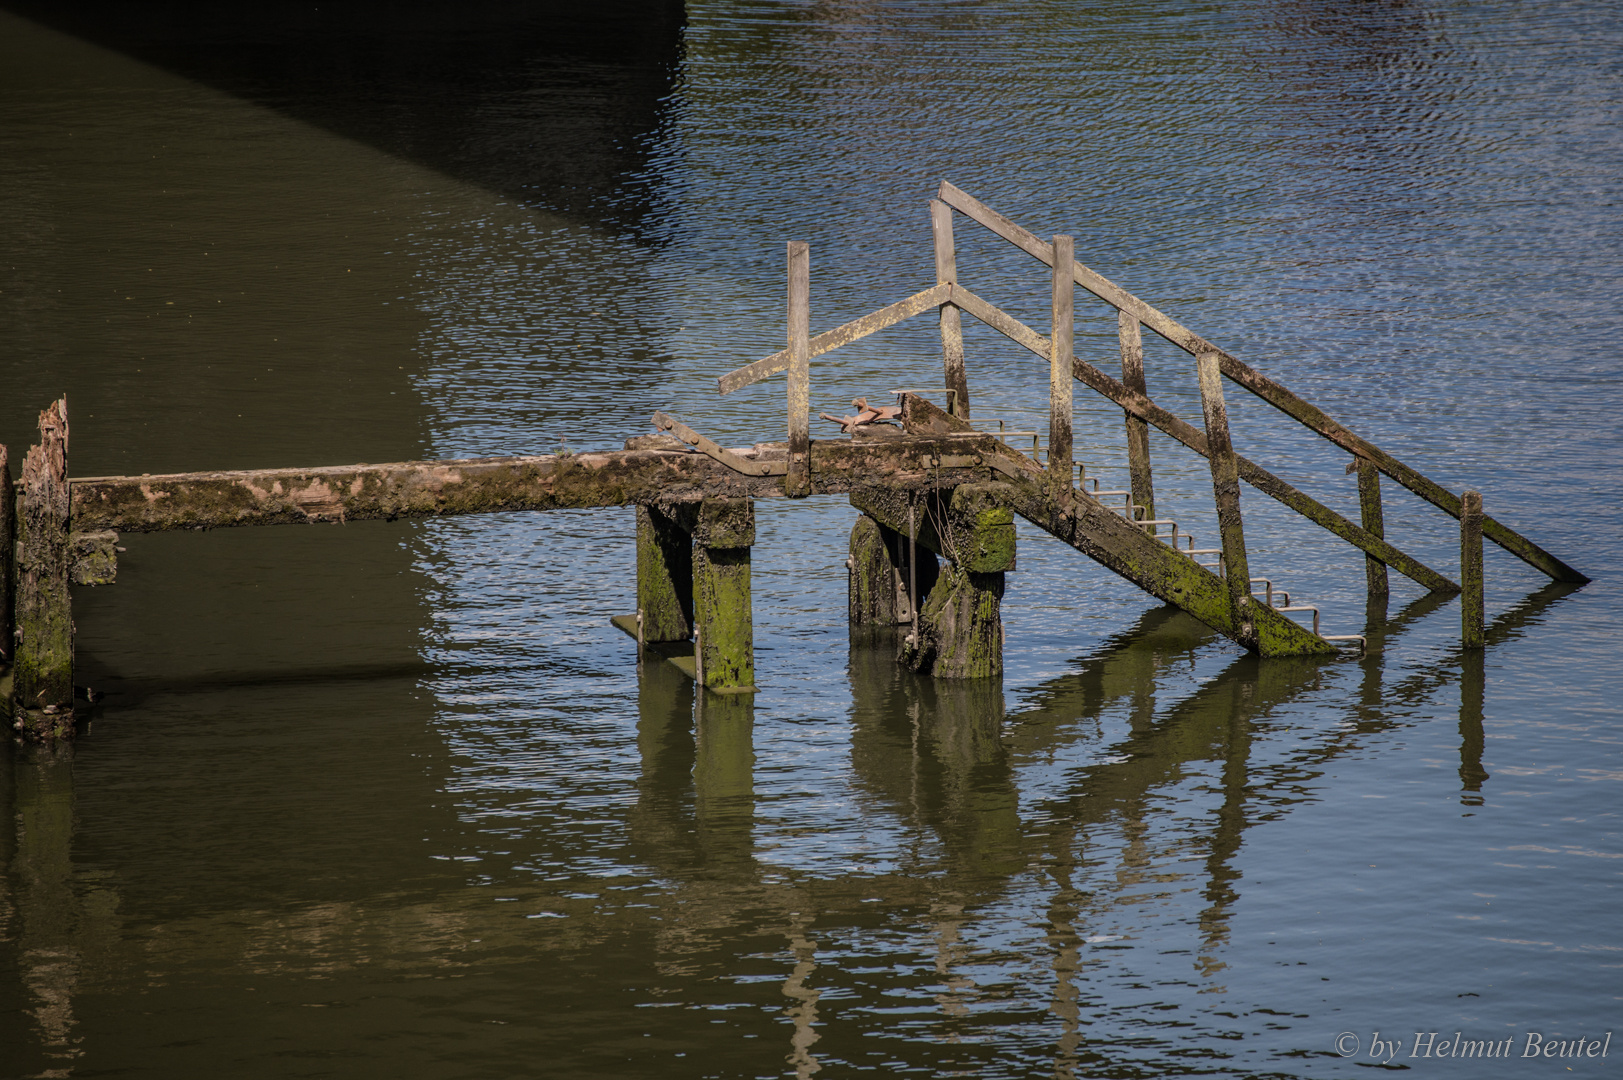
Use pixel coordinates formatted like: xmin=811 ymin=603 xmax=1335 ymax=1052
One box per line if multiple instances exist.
xmin=717 ymin=182 xmax=1589 ymax=656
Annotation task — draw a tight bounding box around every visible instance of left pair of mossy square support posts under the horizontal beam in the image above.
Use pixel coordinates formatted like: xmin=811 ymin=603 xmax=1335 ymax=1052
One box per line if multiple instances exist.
xmin=612 ymin=497 xmax=755 ymax=693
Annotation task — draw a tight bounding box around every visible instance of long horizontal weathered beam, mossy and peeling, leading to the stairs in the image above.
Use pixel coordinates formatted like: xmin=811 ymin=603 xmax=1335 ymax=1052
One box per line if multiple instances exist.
xmin=71 ymin=435 xmax=997 ymax=533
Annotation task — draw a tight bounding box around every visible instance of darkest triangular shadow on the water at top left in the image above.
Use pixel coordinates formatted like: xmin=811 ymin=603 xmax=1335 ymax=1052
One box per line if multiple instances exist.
xmin=3 ymin=0 xmax=685 ymax=224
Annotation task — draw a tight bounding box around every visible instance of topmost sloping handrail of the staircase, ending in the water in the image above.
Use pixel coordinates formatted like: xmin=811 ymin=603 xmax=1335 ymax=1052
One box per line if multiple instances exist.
xmin=938 ymin=180 xmax=1589 ymax=585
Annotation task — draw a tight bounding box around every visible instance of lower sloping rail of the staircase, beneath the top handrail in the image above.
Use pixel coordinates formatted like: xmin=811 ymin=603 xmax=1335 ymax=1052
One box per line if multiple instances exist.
xmin=953 ymin=286 xmax=1459 ymax=593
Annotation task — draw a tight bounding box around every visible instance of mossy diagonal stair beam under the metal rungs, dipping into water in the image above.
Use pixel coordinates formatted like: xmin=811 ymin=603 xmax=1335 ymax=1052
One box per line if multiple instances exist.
xmin=902 ymin=395 xmax=1334 ymax=656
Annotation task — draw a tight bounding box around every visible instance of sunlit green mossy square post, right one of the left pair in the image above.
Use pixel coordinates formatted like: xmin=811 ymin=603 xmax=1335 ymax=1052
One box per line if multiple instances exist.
xmin=693 ymin=499 xmax=755 ymax=692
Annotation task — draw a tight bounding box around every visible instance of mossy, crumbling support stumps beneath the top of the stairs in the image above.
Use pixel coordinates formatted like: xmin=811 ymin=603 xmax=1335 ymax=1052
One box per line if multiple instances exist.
xmin=850 ymin=484 xmax=1014 ymax=679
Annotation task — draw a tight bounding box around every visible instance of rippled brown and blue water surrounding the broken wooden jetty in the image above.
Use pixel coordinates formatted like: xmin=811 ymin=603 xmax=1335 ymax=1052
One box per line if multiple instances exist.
xmin=0 ymin=0 xmax=1623 ymax=1078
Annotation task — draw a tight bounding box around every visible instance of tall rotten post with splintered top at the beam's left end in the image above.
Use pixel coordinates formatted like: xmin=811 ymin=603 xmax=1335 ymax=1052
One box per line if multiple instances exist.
xmin=15 ymin=398 xmax=73 ymax=739
